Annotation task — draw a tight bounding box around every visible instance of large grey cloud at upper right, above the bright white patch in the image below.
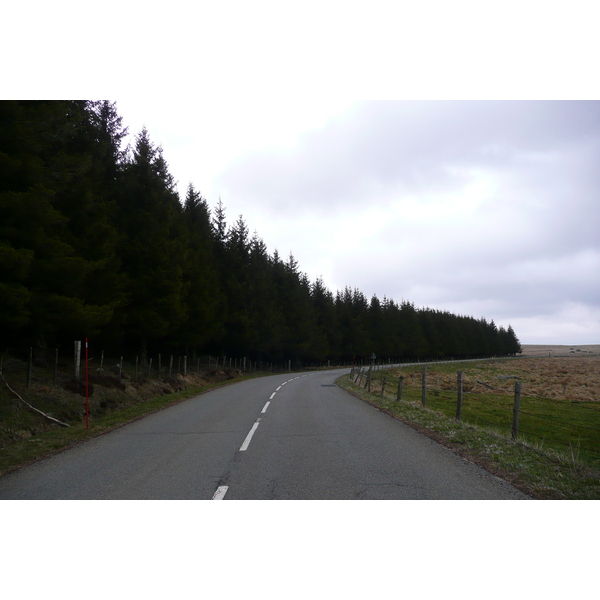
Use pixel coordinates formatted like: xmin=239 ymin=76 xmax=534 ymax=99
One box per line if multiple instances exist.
xmin=219 ymin=101 xmax=600 ymax=216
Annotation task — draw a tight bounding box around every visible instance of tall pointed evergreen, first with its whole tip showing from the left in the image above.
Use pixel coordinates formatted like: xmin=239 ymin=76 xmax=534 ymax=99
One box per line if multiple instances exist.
xmin=113 ymin=128 xmax=188 ymax=357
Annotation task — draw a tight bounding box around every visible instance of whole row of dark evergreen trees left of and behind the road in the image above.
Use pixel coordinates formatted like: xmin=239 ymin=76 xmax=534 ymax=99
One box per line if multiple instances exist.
xmin=0 ymin=101 xmax=520 ymax=362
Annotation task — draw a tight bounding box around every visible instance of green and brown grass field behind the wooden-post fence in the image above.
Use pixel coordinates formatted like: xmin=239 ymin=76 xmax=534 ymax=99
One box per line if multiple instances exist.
xmin=360 ymin=357 xmax=600 ymax=469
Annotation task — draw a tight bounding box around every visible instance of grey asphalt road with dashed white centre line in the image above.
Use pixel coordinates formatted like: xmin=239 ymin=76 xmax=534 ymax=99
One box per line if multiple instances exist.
xmin=0 ymin=370 xmax=528 ymax=500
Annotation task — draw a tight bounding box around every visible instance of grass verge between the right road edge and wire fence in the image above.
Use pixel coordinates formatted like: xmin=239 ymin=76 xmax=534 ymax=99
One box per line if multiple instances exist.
xmin=337 ymin=365 xmax=600 ymax=500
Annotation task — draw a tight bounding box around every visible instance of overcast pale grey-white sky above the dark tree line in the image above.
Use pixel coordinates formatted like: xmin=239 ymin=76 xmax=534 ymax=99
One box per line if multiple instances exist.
xmin=117 ymin=98 xmax=600 ymax=344
